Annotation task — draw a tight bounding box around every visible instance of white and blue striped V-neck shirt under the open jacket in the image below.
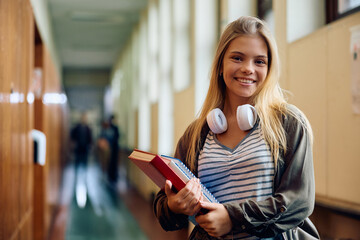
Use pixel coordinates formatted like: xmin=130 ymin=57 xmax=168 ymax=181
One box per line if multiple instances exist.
xmin=198 ymin=124 xmax=275 ymax=239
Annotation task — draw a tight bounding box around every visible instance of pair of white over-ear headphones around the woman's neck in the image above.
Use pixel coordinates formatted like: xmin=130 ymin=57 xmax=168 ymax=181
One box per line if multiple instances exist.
xmin=206 ymin=104 xmax=257 ymax=134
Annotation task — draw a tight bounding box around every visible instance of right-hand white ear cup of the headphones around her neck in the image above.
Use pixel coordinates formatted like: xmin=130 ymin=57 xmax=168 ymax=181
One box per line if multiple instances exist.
xmin=236 ymin=104 xmax=257 ymax=131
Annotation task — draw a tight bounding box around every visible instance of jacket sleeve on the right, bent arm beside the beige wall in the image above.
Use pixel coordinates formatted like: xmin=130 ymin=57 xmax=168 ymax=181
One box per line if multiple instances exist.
xmin=224 ymin=108 xmax=315 ymax=237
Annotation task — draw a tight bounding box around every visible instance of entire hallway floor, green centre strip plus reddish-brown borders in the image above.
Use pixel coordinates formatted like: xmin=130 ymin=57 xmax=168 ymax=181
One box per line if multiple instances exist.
xmin=50 ymin=160 xmax=187 ymax=240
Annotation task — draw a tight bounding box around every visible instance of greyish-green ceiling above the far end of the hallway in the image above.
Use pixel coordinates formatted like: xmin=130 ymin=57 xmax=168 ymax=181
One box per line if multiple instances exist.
xmin=48 ymin=0 xmax=148 ymax=69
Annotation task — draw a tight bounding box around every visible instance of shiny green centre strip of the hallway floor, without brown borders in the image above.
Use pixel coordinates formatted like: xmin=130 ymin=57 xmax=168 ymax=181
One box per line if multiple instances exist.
xmin=66 ymin=163 xmax=147 ymax=240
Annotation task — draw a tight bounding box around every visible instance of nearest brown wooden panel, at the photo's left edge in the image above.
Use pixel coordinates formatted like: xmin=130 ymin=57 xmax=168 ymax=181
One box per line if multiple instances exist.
xmin=0 ymin=0 xmax=34 ymax=239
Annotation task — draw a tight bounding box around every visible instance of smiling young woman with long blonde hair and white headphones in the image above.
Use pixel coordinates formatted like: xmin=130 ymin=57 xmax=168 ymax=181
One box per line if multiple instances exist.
xmin=154 ymin=17 xmax=319 ymax=239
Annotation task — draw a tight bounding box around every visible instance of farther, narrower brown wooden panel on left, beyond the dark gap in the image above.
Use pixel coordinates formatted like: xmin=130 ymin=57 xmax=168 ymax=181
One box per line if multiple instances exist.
xmin=34 ymin=44 xmax=68 ymax=239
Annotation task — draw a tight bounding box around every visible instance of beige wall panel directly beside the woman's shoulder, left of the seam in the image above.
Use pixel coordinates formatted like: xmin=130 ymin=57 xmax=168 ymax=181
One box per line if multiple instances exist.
xmin=288 ymin=29 xmax=328 ymax=194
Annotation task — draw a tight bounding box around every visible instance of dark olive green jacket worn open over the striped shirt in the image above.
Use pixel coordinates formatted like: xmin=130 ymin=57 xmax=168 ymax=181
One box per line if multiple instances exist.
xmin=154 ymin=105 xmax=319 ymax=240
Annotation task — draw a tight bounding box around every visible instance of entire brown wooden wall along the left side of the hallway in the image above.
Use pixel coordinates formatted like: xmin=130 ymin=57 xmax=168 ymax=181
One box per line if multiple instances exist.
xmin=0 ymin=0 xmax=66 ymax=240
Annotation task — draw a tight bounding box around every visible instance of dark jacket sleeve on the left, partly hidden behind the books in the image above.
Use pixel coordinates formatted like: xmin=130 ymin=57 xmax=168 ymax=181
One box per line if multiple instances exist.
xmin=153 ymin=124 xmax=193 ymax=231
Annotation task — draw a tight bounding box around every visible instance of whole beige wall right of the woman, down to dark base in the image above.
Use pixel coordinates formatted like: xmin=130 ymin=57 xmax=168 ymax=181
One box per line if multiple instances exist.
xmin=287 ymin=13 xmax=360 ymax=239
